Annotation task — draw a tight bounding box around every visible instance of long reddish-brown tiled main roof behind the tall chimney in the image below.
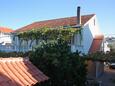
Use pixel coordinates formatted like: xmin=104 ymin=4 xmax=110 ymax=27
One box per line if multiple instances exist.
xmin=14 ymin=14 xmax=95 ymax=32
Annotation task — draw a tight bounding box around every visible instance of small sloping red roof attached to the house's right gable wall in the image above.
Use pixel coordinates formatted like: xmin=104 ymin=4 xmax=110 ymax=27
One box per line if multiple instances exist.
xmin=89 ymin=35 xmax=104 ymax=53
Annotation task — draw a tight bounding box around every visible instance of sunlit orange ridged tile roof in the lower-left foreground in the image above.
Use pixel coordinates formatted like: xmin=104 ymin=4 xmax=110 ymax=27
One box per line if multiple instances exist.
xmin=0 ymin=58 xmax=48 ymax=86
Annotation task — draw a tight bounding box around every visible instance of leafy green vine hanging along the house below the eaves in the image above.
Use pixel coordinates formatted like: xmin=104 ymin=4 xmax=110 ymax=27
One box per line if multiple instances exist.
xmin=17 ymin=26 xmax=82 ymax=45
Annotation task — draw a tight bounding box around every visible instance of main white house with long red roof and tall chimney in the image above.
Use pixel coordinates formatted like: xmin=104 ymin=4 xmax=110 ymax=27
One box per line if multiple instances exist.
xmin=14 ymin=7 xmax=104 ymax=54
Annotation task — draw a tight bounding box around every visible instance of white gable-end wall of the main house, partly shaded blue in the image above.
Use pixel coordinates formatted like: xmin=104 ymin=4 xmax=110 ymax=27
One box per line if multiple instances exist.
xmin=71 ymin=15 xmax=102 ymax=54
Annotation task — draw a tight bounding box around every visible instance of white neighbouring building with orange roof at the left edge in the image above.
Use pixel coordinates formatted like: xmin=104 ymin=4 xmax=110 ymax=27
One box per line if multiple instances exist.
xmin=0 ymin=27 xmax=13 ymax=52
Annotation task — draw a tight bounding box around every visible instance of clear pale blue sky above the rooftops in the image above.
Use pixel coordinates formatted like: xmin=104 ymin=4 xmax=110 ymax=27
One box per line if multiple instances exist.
xmin=0 ymin=0 xmax=115 ymax=35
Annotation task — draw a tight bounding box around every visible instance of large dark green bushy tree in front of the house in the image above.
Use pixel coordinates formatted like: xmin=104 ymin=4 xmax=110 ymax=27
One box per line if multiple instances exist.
xmin=29 ymin=42 xmax=86 ymax=86
